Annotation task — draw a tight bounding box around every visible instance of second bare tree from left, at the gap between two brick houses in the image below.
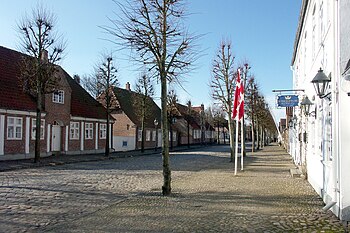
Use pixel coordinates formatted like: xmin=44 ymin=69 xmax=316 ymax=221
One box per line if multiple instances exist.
xmin=95 ymin=55 xmax=119 ymax=157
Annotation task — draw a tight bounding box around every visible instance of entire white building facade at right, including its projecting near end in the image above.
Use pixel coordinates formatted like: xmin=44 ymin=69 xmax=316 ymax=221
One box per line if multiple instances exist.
xmin=289 ymin=0 xmax=350 ymax=221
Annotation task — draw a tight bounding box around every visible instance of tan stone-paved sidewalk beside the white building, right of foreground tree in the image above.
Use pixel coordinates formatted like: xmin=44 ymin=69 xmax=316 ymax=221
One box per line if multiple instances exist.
xmin=48 ymin=146 xmax=344 ymax=232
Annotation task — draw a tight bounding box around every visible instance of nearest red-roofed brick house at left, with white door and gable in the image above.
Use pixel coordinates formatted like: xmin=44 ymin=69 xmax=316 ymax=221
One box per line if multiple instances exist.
xmin=0 ymin=46 xmax=112 ymax=160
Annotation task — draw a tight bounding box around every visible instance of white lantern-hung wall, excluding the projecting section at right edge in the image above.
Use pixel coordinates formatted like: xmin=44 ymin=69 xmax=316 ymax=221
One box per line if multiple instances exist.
xmin=292 ymin=0 xmax=339 ymax=217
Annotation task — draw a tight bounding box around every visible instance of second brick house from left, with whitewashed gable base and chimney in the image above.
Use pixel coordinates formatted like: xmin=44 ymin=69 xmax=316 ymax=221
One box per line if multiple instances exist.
xmin=112 ymin=83 xmax=162 ymax=151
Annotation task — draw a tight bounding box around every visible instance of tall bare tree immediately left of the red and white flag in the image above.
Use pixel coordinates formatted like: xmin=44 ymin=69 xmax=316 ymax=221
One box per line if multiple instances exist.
xmin=210 ymin=41 xmax=236 ymax=162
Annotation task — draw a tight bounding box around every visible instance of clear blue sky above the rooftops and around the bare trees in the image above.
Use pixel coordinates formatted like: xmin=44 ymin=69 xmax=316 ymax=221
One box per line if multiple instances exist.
xmin=0 ymin=0 xmax=301 ymax=123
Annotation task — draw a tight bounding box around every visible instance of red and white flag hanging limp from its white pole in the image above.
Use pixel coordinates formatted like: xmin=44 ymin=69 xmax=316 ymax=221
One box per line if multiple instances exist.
xmin=232 ymin=69 xmax=244 ymax=120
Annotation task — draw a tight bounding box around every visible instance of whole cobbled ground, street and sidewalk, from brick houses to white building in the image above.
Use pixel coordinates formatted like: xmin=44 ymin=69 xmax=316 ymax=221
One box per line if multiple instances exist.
xmin=0 ymin=146 xmax=344 ymax=232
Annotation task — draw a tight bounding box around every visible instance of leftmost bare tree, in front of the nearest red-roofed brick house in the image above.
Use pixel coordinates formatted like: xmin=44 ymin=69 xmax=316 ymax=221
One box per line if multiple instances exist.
xmin=18 ymin=7 xmax=65 ymax=163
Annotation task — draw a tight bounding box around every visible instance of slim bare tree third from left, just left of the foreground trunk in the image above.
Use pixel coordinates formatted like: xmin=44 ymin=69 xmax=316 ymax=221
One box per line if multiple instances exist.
xmin=133 ymin=74 xmax=154 ymax=152
